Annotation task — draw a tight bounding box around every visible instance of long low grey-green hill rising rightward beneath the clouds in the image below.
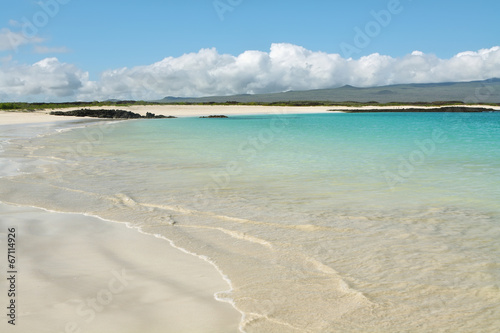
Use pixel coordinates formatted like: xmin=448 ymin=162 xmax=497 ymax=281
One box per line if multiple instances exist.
xmin=159 ymin=78 xmax=500 ymax=103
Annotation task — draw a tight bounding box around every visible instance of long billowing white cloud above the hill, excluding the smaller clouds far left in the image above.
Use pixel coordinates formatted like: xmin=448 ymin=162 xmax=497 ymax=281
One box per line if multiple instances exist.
xmin=90 ymin=44 xmax=500 ymax=99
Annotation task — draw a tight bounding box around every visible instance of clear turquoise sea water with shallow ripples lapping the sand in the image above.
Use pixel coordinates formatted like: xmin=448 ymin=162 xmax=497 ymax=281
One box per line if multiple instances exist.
xmin=0 ymin=110 xmax=500 ymax=332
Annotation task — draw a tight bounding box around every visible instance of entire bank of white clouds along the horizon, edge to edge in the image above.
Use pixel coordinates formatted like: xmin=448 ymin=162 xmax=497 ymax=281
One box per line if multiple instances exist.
xmin=0 ymin=43 xmax=500 ymax=101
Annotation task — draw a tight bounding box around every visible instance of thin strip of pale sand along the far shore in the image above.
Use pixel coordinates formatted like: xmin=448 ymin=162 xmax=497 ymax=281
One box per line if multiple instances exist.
xmin=0 ymin=105 xmax=500 ymax=125
